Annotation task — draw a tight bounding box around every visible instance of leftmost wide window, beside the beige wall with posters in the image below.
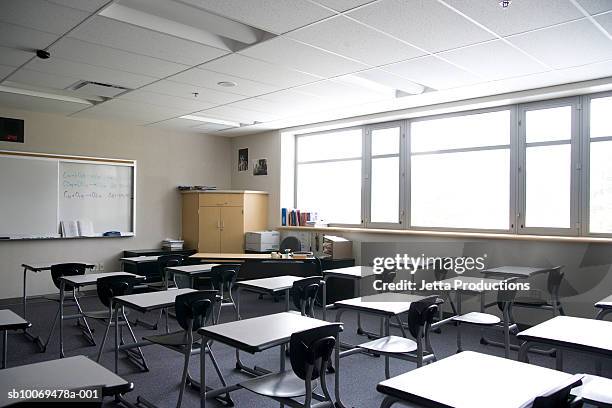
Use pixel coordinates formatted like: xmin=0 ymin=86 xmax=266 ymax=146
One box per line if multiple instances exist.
xmin=296 ymin=129 xmax=363 ymax=224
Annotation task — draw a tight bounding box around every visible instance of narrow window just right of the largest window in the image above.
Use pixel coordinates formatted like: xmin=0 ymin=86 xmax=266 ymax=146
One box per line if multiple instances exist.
xmin=520 ymin=100 xmax=576 ymax=233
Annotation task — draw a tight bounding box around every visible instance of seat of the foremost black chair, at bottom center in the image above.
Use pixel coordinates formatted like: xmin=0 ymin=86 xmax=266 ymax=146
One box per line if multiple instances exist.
xmin=238 ymin=371 xmax=318 ymax=398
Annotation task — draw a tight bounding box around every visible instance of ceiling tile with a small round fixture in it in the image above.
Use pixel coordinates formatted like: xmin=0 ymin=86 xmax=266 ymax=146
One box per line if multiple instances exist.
xmin=171 ymin=68 xmax=280 ymax=96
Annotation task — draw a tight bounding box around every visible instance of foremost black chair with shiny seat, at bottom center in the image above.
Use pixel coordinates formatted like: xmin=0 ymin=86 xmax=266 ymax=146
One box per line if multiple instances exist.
xmin=239 ymin=323 xmax=342 ymax=408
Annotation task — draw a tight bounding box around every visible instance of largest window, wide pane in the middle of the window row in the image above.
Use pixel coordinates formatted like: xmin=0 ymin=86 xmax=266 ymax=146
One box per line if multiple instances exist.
xmin=410 ymin=110 xmax=511 ymax=231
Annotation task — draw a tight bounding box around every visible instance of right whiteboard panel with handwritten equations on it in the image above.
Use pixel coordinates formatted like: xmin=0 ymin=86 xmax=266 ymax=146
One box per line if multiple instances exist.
xmin=59 ymin=161 xmax=133 ymax=234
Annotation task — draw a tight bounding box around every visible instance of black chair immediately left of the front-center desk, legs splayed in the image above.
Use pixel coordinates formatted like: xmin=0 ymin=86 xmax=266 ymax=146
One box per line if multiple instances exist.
xmin=137 ymin=290 xmax=229 ymax=408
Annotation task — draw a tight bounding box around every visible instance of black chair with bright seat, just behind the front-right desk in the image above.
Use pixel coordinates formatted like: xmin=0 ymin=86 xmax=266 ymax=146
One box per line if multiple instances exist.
xmin=357 ymin=295 xmax=441 ymax=379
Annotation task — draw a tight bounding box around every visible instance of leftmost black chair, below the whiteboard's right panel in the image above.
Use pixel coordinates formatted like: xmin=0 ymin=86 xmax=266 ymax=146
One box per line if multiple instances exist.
xmin=43 ymin=263 xmax=96 ymax=350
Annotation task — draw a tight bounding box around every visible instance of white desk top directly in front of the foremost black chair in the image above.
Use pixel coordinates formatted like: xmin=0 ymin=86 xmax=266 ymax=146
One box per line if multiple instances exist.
xmin=198 ymin=312 xmax=335 ymax=353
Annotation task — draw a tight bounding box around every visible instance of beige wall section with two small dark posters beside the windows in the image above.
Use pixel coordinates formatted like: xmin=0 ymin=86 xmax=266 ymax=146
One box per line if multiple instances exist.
xmin=231 ymin=131 xmax=281 ymax=227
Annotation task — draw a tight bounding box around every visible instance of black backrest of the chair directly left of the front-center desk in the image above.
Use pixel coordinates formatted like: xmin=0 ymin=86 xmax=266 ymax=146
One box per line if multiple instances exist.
xmin=174 ymin=290 xmax=221 ymax=330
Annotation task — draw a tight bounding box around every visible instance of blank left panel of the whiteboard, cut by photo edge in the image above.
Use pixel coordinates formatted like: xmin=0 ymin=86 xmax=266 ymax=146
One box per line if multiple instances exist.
xmin=0 ymin=156 xmax=58 ymax=238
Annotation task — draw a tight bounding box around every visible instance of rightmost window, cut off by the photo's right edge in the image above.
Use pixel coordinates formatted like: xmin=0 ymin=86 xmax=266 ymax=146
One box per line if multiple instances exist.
xmin=588 ymin=97 xmax=612 ymax=234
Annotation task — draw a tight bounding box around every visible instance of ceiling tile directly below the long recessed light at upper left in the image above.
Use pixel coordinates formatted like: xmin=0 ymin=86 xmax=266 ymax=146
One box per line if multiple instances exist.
xmin=70 ymin=16 xmax=228 ymax=66
